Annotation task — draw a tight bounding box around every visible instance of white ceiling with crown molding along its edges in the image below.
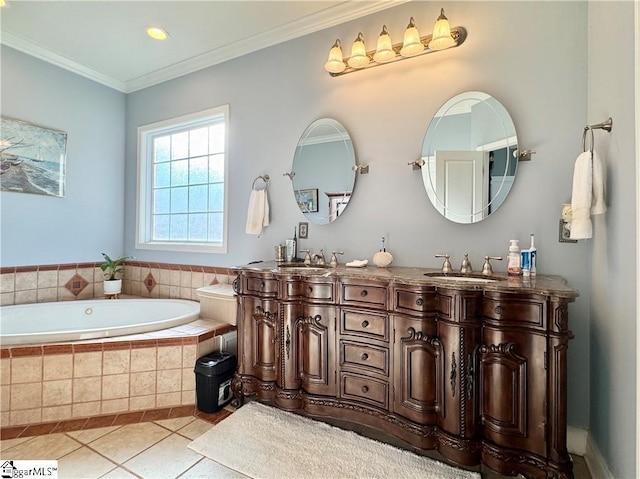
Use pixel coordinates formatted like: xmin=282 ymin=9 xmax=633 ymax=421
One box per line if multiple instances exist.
xmin=0 ymin=0 xmax=407 ymax=93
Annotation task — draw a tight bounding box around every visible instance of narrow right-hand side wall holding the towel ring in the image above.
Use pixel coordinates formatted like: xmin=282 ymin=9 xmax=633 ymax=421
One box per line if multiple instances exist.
xmin=587 ymin=2 xmax=640 ymax=478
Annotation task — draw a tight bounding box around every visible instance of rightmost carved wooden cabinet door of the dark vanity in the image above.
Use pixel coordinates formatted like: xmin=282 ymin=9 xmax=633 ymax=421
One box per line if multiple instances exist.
xmin=477 ymin=325 xmax=547 ymax=457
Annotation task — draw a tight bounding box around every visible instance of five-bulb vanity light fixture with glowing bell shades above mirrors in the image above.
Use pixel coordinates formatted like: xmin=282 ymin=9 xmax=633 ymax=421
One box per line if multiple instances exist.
xmin=324 ymin=8 xmax=467 ymax=76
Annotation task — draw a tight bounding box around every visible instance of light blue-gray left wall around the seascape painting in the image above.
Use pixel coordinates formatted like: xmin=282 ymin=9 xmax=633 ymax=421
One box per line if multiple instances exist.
xmin=0 ymin=46 xmax=126 ymax=266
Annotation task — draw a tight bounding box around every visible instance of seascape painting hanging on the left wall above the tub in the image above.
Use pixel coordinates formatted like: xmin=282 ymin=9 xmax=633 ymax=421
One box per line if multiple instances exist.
xmin=0 ymin=116 xmax=67 ymax=197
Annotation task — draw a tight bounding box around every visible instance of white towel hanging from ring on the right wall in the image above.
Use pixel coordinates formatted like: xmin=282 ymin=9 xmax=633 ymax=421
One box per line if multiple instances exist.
xmin=569 ymin=151 xmax=607 ymax=239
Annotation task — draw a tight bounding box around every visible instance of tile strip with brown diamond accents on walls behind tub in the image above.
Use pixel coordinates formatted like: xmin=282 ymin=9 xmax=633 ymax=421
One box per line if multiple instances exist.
xmin=0 ymin=261 xmax=235 ymax=306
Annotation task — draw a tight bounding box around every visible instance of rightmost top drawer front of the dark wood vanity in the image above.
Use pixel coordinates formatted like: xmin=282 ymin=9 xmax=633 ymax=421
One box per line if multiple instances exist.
xmin=482 ymin=296 xmax=547 ymax=328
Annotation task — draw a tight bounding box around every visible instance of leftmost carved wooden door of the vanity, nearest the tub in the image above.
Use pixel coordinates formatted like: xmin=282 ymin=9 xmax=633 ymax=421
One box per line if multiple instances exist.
xmin=238 ymin=296 xmax=278 ymax=381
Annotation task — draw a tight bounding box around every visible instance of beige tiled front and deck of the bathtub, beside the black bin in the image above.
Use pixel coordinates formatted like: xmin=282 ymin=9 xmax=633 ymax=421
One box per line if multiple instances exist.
xmin=0 ymin=319 xmax=235 ymax=431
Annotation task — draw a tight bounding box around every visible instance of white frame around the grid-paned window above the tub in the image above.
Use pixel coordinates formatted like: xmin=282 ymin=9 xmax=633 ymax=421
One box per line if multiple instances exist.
xmin=136 ymin=105 xmax=229 ymax=253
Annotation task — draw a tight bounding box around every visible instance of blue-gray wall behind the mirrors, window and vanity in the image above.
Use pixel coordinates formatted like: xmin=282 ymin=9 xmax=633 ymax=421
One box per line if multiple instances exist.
xmin=125 ymin=2 xmax=589 ymax=429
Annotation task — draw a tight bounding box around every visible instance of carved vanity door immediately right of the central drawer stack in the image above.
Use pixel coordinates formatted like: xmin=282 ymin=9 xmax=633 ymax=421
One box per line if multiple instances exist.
xmin=392 ymin=315 xmax=445 ymax=425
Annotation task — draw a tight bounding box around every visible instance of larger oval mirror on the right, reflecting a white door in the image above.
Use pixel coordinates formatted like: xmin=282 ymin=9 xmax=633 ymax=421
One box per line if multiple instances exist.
xmin=422 ymin=91 xmax=518 ymax=223
